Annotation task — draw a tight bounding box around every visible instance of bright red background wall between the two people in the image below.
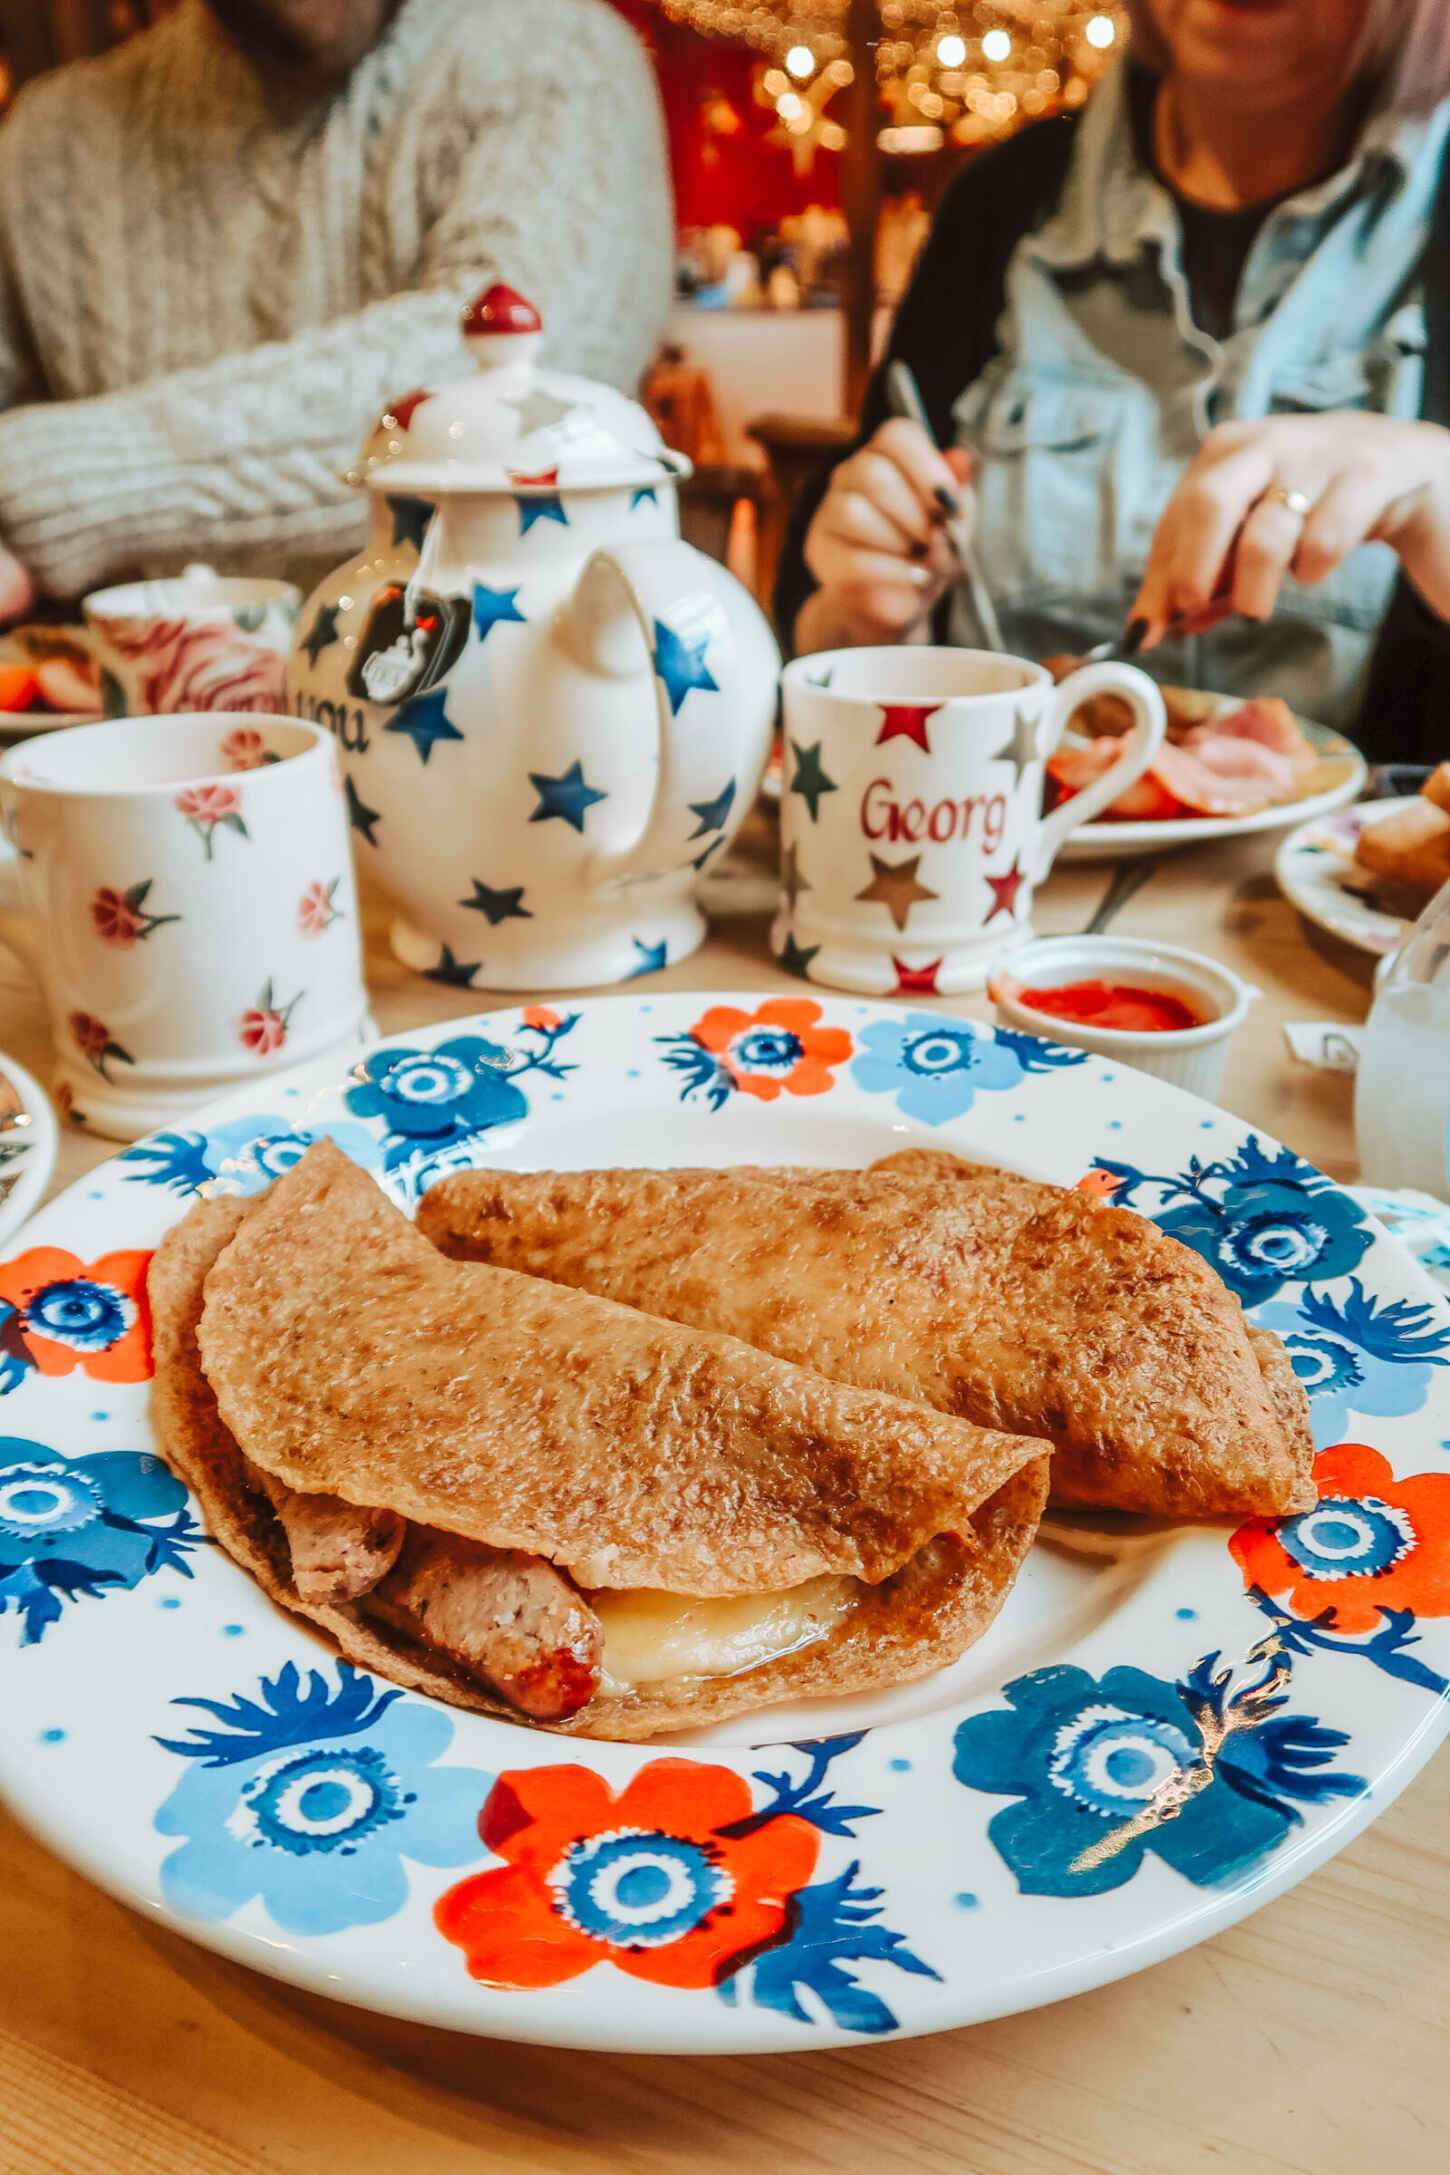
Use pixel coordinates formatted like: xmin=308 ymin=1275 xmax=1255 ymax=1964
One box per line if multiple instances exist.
xmin=600 ymin=0 xmax=841 ymax=241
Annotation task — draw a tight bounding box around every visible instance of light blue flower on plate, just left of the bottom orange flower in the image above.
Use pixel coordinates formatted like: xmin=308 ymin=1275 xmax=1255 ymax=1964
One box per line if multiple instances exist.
xmin=157 ymin=1662 xmax=493 ymax=1934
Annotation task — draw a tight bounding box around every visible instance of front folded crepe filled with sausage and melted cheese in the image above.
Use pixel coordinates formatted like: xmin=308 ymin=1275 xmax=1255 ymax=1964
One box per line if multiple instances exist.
xmin=150 ymin=1142 xmax=1048 ymax=1738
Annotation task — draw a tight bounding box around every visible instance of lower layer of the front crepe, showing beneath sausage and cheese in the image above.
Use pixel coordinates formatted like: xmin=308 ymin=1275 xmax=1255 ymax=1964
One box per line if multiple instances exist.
xmin=150 ymin=1174 xmax=1046 ymax=1740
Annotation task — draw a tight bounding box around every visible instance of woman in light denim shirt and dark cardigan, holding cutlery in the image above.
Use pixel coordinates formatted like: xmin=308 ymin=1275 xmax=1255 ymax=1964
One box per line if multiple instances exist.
xmin=778 ymin=0 xmax=1450 ymax=761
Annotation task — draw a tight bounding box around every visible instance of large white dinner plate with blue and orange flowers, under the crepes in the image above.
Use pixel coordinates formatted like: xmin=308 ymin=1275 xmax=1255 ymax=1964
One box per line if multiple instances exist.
xmin=0 ymin=994 xmax=1450 ymax=2053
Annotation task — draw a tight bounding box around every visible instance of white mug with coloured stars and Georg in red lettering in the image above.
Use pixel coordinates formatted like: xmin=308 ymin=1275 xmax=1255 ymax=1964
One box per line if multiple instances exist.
xmin=772 ymin=646 xmax=1163 ymax=996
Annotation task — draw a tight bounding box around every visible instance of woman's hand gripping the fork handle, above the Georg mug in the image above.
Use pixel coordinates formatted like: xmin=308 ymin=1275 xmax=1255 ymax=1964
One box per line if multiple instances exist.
xmin=796 ymin=420 xmax=974 ymax=650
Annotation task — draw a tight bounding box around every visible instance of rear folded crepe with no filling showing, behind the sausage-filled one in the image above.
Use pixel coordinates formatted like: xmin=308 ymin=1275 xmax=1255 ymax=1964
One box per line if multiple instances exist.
xmin=417 ymin=1157 xmax=1315 ymax=1518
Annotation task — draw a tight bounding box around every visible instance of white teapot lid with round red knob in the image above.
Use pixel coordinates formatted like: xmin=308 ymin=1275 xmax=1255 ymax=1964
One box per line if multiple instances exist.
xmin=359 ymin=285 xmax=691 ymax=498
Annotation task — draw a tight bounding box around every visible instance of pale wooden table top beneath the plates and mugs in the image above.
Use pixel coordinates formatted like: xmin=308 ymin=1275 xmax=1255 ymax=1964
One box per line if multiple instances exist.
xmin=0 ymin=817 xmax=1450 ymax=2175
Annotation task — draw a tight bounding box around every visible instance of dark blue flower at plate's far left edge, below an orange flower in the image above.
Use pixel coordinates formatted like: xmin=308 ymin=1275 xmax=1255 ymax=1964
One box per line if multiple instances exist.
xmin=0 ymin=1436 xmax=204 ymax=1646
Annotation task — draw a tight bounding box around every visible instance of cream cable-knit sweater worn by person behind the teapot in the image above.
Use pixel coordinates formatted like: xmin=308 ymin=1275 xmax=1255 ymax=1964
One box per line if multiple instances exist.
xmin=0 ymin=0 xmax=672 ymax=596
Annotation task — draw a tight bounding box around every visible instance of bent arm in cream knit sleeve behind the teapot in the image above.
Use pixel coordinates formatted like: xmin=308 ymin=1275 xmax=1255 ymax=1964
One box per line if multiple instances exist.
xmin=0 ymin=24 xmax=670 ymax=596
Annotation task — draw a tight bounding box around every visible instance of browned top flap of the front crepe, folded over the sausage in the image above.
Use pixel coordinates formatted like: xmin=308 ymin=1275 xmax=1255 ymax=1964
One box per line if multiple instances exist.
xmin=198 ymin=1142 xmax=1041 ymax=1594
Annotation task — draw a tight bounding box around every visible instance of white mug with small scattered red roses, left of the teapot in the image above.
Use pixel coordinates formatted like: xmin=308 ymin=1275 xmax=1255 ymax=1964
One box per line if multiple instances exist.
xmin=0 ymin=711 xmax=372 ymax=1140
